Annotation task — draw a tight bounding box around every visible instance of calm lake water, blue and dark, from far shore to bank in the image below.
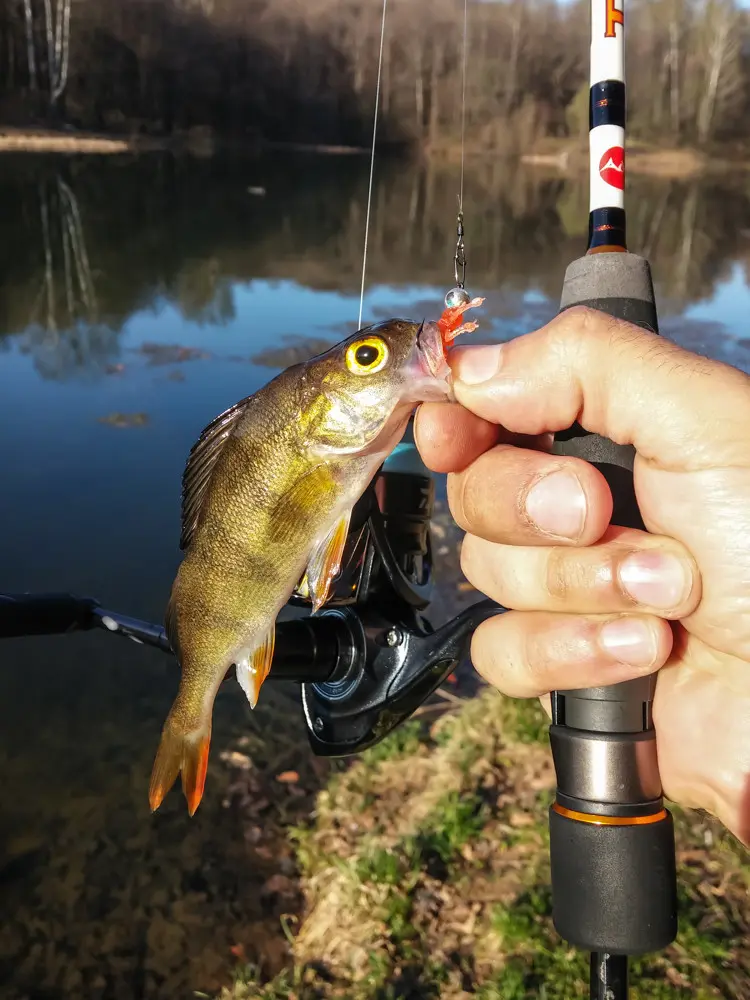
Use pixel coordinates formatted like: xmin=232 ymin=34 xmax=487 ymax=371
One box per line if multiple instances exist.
xmin=0 ymin=154 xmax=750 ymax=1000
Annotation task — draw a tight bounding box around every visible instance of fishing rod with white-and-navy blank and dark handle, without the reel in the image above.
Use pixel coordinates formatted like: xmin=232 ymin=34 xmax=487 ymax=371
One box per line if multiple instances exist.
xmin=549 ymin=0 xmax=677 ymax=1000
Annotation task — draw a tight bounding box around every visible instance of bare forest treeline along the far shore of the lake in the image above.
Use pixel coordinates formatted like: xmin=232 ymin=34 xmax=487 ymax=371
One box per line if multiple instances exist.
xmin=0 ymin=0 xmax=750 ymax=152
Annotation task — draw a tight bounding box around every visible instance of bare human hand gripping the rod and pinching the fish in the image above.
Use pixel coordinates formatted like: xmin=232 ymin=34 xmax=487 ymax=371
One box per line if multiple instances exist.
xmin=415 ymin=307 xmax=750 ymax=844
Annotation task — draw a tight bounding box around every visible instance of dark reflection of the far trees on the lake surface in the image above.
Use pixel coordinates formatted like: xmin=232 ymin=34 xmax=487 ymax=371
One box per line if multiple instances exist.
xmin=0 ymin=155 xmax=750 ymax=379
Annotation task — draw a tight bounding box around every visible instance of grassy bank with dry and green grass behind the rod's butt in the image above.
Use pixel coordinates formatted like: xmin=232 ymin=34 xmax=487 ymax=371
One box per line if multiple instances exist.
xmin=209 ymin=690 xmax=750 ymax=1000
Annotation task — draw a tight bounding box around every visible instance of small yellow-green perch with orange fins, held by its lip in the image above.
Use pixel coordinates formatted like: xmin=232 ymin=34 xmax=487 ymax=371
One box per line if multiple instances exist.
xmin=149 ymin=299 xmax=483 ymax=816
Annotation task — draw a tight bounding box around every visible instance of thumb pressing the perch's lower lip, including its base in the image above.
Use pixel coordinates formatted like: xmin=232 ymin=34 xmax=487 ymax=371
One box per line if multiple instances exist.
xmin=451 ymin=306 xmax=750 ymax=469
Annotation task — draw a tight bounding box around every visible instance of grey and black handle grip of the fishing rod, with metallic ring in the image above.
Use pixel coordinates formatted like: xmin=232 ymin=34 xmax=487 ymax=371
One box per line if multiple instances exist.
xmin=550 ymin=253 xmax=677 ymax=955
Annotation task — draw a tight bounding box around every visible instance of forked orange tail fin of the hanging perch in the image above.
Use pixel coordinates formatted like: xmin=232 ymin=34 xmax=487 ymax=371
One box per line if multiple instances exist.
xmin=148 ymin=719 xmax=211 ymax=816
